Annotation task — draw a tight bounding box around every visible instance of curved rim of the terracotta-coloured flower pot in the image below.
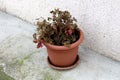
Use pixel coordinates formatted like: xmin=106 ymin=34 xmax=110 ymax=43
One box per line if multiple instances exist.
xmin=43 ymin=29 xmax=84 ymax=50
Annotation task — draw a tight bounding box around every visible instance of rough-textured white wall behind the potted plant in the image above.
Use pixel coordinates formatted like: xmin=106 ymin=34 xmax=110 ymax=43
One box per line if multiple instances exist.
xmin=0 ymin=0 xmax=120 ymax=61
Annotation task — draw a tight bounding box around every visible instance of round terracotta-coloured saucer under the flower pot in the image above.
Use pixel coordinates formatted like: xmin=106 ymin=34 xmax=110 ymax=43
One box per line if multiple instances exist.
xmin=47 ymin=55 xmax=80 ymax=70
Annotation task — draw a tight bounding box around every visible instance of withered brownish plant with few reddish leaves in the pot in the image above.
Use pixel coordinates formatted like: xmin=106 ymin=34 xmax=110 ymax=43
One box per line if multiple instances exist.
xmin=33 ymin=9 xmax=80 ymax=48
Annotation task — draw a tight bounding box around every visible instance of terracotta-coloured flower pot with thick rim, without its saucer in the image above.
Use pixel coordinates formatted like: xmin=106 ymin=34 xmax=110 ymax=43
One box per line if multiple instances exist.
xmin=43 ymin=30 xmax=84 ymax=67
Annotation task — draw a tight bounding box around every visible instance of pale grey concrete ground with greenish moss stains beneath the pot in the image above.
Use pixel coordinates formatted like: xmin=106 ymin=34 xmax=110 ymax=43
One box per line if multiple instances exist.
xmin=0 ymin=12 xmax=120 ymax=80
